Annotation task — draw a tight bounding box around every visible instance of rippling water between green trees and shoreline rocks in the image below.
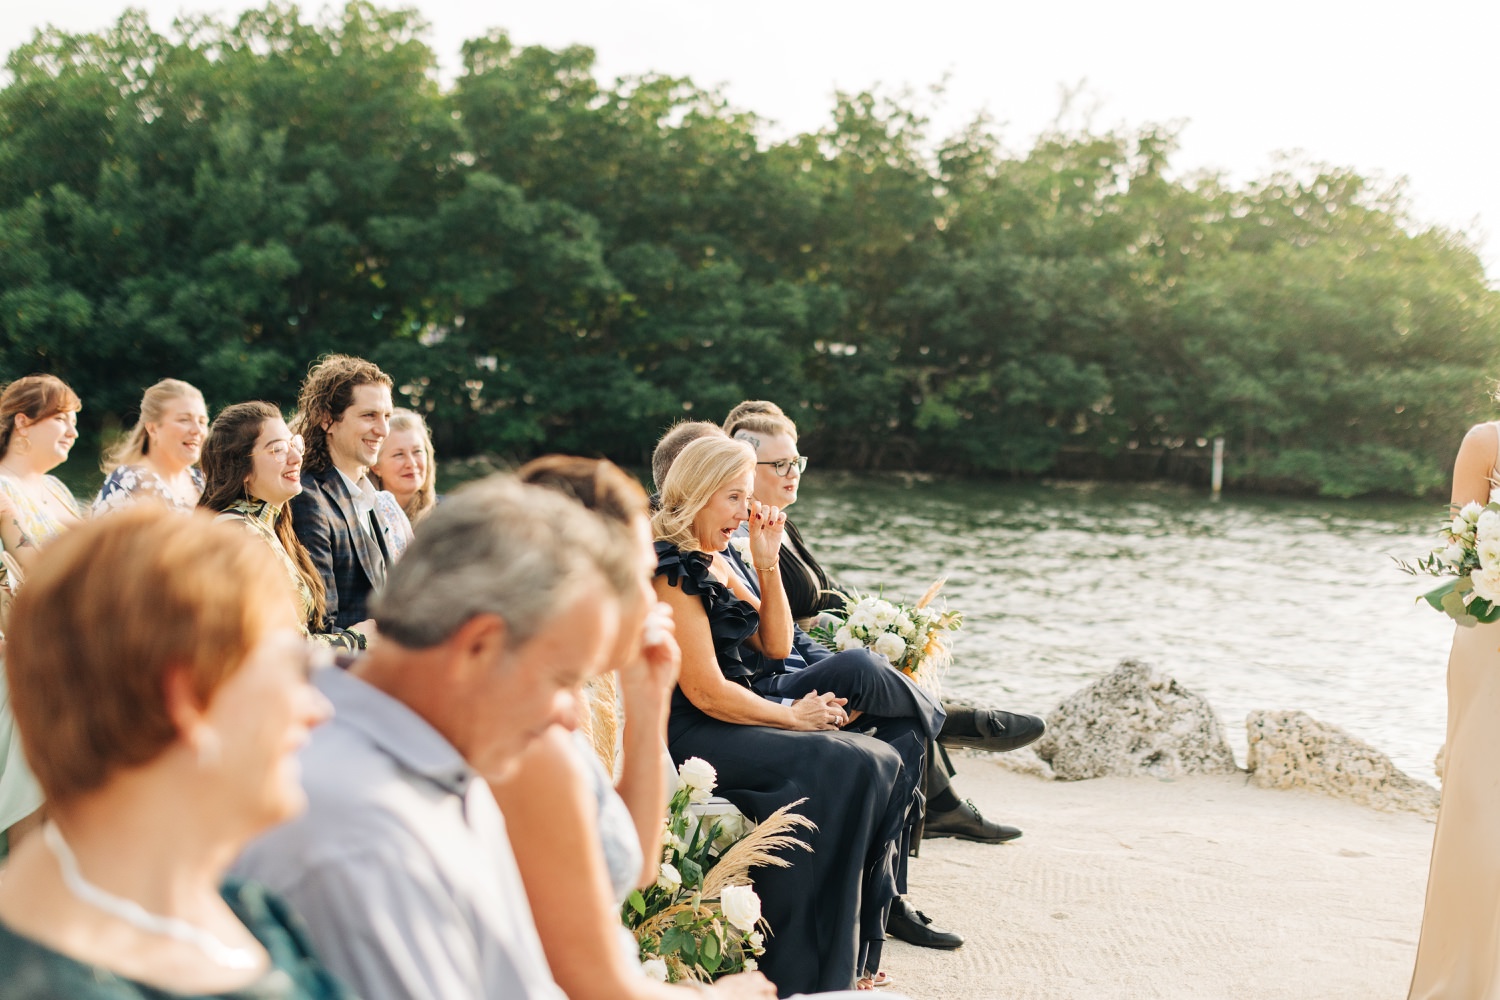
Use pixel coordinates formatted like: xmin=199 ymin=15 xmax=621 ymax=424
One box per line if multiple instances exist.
xmin=792 ymin=474 xmax=1454 ymax=783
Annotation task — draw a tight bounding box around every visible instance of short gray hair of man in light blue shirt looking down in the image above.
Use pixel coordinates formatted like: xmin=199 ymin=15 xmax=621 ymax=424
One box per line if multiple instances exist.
xmin=374 ymin=474 xmax=641 ymax=649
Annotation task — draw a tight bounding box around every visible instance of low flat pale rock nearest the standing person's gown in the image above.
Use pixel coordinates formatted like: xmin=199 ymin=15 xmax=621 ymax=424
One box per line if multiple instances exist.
xmin=1245 ymin=712 xmax=1439 ymax=817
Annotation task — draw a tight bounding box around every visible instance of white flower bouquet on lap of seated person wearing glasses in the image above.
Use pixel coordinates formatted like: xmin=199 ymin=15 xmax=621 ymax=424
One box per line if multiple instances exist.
xmin=810 ymin=580 xmax=963 ymax=682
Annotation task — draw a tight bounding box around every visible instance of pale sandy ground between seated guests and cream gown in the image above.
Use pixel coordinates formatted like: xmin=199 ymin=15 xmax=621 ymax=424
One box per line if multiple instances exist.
xmin=884 ymin=756 xmax=1433 ymax=1000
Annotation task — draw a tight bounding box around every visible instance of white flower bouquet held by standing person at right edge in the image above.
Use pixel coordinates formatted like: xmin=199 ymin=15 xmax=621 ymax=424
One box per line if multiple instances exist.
xmin=1397 ymin=501 xmax=1500 ymax=625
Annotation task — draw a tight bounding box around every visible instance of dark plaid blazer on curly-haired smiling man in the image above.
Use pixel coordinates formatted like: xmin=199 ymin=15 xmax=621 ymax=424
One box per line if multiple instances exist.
xmin=291 ymin=465 xmax=390 ymax=628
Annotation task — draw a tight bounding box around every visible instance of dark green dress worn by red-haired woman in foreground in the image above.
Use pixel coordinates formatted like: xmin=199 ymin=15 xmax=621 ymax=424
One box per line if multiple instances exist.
xmin=0 ymin=882 xmax=354 ymax=1000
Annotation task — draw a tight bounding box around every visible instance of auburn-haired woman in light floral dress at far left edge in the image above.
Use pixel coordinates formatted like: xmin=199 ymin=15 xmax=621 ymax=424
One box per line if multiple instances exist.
xmin=0 ymin=375 xmax=83 ymax=849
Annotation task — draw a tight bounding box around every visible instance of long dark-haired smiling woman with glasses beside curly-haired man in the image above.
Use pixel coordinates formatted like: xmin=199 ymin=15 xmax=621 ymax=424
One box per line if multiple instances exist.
xmin=198 ymin=402 xmax=375 ymax=652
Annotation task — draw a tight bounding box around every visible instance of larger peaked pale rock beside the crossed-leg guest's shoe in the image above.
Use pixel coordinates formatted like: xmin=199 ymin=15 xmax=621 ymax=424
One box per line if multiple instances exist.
xmin=1032 ymin=660 xmax=1239 ymax=781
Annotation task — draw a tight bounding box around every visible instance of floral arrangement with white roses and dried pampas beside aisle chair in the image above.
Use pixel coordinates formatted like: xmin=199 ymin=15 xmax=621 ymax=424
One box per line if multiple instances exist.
xmin=621 ymin=757 xmax=813 ymax=982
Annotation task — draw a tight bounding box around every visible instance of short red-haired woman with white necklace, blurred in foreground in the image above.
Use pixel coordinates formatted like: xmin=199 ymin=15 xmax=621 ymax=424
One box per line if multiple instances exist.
xmin=0 ymin=504 xmax=351 ymax=1000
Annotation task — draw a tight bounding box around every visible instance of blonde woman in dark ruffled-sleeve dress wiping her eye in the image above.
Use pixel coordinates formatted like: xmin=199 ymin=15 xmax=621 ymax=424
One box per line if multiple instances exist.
xmin=651 ymin=435 xmax=921 ymax=996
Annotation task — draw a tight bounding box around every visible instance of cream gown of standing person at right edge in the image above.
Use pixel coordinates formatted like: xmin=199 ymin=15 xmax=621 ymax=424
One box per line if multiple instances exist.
xmin=1409 ymin=497 xmax=1500 ymax=1000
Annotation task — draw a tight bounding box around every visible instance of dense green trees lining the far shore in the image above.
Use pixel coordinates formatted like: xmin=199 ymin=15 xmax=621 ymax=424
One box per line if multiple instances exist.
xmin=0 ymin=1 xmax=1500 ymax=496
